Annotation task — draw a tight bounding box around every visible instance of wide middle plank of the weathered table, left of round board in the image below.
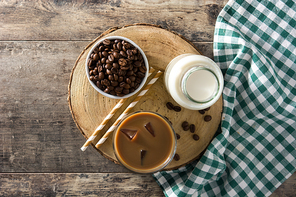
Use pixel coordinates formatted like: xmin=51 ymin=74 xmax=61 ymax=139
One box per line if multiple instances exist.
xmin=0 ymin=42 xmax=127 ymax=172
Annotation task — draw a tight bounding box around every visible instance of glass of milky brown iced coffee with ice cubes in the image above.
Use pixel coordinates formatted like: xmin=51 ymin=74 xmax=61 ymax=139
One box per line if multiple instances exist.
xmin=113 ymin=111 xmax=177 ymax=173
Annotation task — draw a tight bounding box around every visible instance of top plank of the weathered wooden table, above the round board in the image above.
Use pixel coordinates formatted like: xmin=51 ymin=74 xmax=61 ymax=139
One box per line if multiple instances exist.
xmin=0 ymin=0 xmax=227 ymax=42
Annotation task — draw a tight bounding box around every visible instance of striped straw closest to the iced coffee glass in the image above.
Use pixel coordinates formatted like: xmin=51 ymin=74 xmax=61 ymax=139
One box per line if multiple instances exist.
xmin=96 ymin=71 xmax=162 ymax=148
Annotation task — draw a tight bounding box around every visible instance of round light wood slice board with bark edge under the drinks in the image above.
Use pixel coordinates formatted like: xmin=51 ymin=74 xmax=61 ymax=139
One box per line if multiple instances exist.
xmin=68 ymin=24 xmax=222 ymax=170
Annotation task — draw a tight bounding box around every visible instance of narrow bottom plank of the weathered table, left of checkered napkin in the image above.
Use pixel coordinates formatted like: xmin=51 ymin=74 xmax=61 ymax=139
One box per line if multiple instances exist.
xmin=0 ymin=173 xmax=164 ymax=197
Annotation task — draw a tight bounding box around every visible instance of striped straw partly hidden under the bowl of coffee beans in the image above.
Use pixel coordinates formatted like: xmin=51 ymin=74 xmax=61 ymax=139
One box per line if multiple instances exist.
xmin=80 ymin=68 xmax=154 ymax=151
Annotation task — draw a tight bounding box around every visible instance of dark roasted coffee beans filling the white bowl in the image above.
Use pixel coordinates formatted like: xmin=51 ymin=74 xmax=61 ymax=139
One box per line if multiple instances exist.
xmin=87 ymin=39 xmax=147 ymax=97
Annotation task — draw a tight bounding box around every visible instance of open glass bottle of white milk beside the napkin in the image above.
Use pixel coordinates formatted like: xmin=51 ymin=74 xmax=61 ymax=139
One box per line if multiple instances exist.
xmin=164 ymin=54 xmax=224 ymax=110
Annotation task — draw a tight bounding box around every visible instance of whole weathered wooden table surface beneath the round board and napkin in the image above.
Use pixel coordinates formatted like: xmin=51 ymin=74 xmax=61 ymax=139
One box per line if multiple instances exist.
xmin=0 ymin=0 xmax=296 ymax=197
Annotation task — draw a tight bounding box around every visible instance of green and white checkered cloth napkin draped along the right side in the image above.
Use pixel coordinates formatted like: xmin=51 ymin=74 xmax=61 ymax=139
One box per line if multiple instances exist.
xmin=153 ymin=0 xmax=296 ymax=196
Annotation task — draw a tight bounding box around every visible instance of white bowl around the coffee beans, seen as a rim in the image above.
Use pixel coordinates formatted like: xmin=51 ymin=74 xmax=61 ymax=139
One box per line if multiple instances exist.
xmin=85 ymin=36 xmax=149 ymax=99
